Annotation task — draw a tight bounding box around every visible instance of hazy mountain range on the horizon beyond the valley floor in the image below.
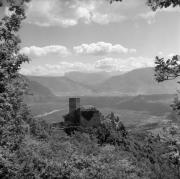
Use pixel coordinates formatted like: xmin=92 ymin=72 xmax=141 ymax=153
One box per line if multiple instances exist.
xmin=27 ymin=68 xmax=178 ymax=96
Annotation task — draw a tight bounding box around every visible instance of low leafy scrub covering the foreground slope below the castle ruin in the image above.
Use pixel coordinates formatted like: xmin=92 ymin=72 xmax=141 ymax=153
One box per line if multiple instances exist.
xmin=7 ymin=119 xmax=180 ymax=179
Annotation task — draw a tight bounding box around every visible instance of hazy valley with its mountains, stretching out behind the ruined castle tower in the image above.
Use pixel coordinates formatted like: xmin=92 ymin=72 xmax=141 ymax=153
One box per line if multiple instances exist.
xmin=25 ymin=68 xmax=180 ymax=132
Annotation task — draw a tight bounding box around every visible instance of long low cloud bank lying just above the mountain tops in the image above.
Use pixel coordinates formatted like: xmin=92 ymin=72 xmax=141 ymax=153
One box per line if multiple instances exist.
xmin=21 ymin=57 xmax=154 ymax=76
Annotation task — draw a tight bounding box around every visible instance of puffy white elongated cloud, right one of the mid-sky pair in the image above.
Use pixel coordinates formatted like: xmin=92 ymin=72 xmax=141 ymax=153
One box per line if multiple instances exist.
xmin=73 ymin=42 xmax=136 ymax=55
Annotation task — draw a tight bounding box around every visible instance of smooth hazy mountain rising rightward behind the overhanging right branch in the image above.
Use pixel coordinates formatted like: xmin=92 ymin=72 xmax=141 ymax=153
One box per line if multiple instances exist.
xmin=96 ymin=68 xmax=178 ymax=95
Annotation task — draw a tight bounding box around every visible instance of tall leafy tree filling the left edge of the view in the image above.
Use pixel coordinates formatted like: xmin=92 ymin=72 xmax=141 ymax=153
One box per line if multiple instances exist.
xmin=0 ymin=0 xmax=29 ymax=178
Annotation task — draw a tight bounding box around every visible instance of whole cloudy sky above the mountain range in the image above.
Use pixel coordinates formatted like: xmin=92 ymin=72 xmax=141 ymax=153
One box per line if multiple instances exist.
xmin=2 ymin=0 xmax=180 ymax=76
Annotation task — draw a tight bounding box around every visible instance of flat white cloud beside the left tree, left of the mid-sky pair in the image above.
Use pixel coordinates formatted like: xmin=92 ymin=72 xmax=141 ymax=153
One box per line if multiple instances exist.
xmin=20 ymin=45 xmax=70 ymax=57
